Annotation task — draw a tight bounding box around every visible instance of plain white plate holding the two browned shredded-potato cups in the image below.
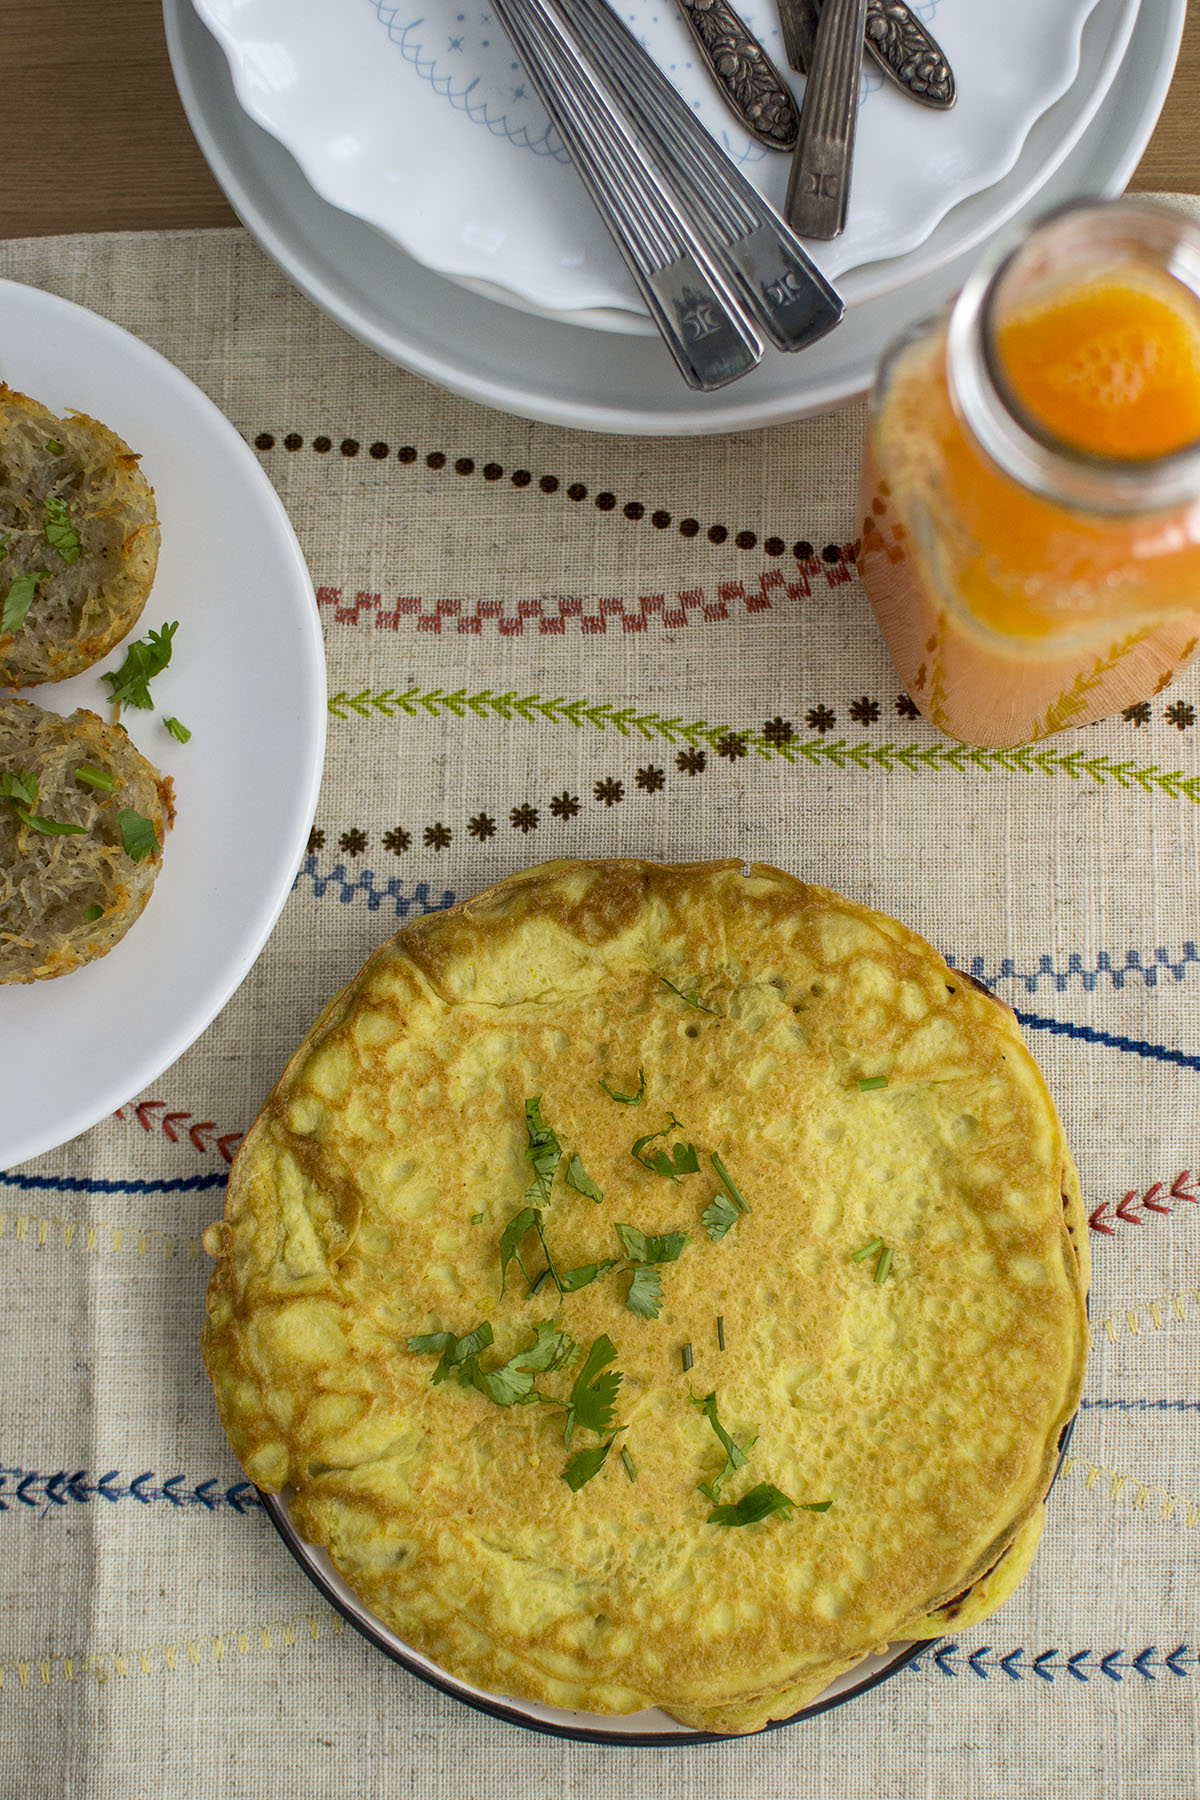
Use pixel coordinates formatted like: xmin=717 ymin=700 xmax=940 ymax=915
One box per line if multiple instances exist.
xmin=0 ymin=281 xmax=326 ymax=1168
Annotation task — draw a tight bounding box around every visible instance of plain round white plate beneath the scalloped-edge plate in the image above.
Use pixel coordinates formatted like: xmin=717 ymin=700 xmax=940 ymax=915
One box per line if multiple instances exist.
xmin=164 ymin=0 xmax=1186 ymax=436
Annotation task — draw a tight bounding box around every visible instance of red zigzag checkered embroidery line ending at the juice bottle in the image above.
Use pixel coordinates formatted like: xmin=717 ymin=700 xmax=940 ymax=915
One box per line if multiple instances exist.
xmin=317 ymin=558 xmax=855 ymax=637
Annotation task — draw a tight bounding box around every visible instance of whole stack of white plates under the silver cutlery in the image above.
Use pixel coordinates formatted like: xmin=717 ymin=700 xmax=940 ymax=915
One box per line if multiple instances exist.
xmin=166 ymin=0 xmax=1186 ymax=434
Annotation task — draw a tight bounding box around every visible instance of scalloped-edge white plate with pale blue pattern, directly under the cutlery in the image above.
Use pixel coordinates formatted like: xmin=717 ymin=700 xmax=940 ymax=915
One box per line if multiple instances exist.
xmin=196 ymin=0 xmax=1103 ymax=327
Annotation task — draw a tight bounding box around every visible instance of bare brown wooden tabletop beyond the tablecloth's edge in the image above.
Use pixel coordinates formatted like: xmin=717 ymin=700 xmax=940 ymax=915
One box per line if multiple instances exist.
xmin=0 ymin=0 xmax=1200 ymax=238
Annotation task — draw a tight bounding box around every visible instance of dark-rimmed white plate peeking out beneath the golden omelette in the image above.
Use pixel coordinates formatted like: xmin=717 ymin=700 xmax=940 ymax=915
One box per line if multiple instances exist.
xmin=259 ymin=1489 xmax=932 ymax=1744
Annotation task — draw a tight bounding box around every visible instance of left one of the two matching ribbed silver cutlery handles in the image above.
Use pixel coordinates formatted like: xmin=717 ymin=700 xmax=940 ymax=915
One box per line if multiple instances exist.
xmin=495 ymin=0 xmax=763 ymax=391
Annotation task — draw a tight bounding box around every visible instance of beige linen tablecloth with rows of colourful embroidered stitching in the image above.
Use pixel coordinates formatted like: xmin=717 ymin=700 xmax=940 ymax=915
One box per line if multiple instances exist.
xmin=0 ymin=230 xmax=1200 ymax=1800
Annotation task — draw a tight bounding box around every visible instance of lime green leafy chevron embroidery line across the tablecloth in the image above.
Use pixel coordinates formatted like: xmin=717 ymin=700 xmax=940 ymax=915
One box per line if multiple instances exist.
xmin=329 ymin=688 xmax=1200 ymax=805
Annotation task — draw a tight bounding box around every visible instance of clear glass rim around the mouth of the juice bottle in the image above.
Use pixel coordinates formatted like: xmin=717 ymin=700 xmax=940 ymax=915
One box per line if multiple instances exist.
xmin=948 ymin=200 xmax=1200 ymax=513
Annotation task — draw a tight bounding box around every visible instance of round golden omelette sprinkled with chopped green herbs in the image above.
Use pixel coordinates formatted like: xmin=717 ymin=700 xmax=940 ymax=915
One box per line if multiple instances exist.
xmin=205 ymin=860 xmax=1087 ymax=1732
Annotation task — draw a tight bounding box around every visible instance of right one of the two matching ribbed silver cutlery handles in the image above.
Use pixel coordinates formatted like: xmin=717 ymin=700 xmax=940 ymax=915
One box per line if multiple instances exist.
xmin=529 ymin=0 xmax=844 ymax=351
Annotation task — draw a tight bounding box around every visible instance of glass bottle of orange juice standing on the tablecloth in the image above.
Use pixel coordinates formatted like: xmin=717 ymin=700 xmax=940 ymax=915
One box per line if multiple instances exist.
xmin=858 ymin=200 xmax=1200 ymax=745
